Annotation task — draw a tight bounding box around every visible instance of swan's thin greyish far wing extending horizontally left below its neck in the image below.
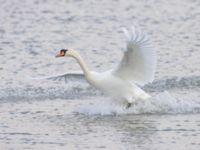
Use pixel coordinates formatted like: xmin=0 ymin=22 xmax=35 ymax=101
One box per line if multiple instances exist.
xmin=34 ymin=72 xmax=85 ymax=83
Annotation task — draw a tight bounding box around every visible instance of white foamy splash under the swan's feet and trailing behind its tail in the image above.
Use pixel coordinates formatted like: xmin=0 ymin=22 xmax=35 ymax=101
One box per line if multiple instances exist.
xmin=75 ymin=91 xmax=200 ymax=115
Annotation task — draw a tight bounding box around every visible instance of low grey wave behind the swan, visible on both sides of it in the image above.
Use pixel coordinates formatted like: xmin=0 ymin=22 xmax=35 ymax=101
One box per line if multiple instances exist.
xmin=0 ymin=76 xmax=200 ymax=101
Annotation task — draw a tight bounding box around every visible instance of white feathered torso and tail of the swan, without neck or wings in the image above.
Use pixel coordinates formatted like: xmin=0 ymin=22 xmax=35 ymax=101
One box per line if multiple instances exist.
xmin=89 ymin=70 xmax=150 ymax=103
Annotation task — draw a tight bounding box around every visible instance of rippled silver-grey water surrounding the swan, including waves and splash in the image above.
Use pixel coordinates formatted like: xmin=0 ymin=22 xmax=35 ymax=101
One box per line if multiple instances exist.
xmin=0 ymin=0 xmax=200 ymax=150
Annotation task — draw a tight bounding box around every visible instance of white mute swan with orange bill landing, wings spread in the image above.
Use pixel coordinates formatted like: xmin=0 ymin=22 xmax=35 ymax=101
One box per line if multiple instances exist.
xmin=49 ymin=27 xmax=156 ymax=108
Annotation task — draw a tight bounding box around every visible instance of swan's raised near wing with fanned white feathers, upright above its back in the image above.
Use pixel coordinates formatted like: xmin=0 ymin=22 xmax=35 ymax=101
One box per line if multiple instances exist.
xmin=113 ymin=27 xmax=156 ymax=85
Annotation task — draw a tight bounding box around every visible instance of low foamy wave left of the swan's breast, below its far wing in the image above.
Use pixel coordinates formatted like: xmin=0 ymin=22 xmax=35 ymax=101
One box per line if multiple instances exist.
xmin=0 ymin=85 xmax=100 ymax=102
